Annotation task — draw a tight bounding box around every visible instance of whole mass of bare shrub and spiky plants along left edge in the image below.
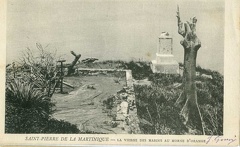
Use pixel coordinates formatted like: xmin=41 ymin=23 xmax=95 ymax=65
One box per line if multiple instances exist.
xmin=5 ymin=44 xmax=80 ymax=133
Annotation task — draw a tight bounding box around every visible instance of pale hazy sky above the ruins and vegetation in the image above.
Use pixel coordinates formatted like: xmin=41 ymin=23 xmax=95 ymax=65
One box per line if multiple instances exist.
xmin=7 ymin=0 xmax=224 ymax=74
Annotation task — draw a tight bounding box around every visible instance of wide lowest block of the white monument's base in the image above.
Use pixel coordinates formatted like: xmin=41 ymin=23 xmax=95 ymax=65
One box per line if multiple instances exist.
xmin=151 ymin=60 xmax=179 ymax=74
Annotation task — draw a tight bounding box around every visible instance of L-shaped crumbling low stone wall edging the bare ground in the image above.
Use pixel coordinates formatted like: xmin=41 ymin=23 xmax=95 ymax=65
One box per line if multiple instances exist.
xmin=77 ymin=68 xmax=141 ymax=134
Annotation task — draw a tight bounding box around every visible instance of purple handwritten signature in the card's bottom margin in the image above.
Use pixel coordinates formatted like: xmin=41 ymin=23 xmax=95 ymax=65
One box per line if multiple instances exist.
xmin=206 ymin=135 xmax=237 ymax=145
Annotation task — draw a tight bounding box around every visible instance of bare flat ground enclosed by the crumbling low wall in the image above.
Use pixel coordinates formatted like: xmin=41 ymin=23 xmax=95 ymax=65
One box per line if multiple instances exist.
xmin=52 ymin=73 xmax=126 ymax=134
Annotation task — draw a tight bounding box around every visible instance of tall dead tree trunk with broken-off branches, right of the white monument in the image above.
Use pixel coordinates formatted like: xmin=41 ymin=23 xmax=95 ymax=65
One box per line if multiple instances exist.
xmin=176 ymin=5 xmax=204 ymax=134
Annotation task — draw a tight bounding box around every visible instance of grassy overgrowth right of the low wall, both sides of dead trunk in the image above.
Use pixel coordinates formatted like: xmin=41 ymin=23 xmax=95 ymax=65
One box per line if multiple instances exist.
xmin=124 ymin=63 xmax=224 ymax=135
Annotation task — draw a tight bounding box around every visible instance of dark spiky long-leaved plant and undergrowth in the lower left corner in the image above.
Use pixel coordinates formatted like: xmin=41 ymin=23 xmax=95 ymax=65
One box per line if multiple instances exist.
xmin=5 ymin=79 xmax=79 ymax=133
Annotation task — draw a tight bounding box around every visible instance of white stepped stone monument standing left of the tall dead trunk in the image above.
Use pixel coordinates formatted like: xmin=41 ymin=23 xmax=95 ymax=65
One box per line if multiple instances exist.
xmin=151 ymin=32 xmax=179 ymax=74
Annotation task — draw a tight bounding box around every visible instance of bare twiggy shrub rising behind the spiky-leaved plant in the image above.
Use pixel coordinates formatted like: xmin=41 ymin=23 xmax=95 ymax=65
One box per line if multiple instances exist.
xmin=16 ymin=43 xmax=60 ymax=97
